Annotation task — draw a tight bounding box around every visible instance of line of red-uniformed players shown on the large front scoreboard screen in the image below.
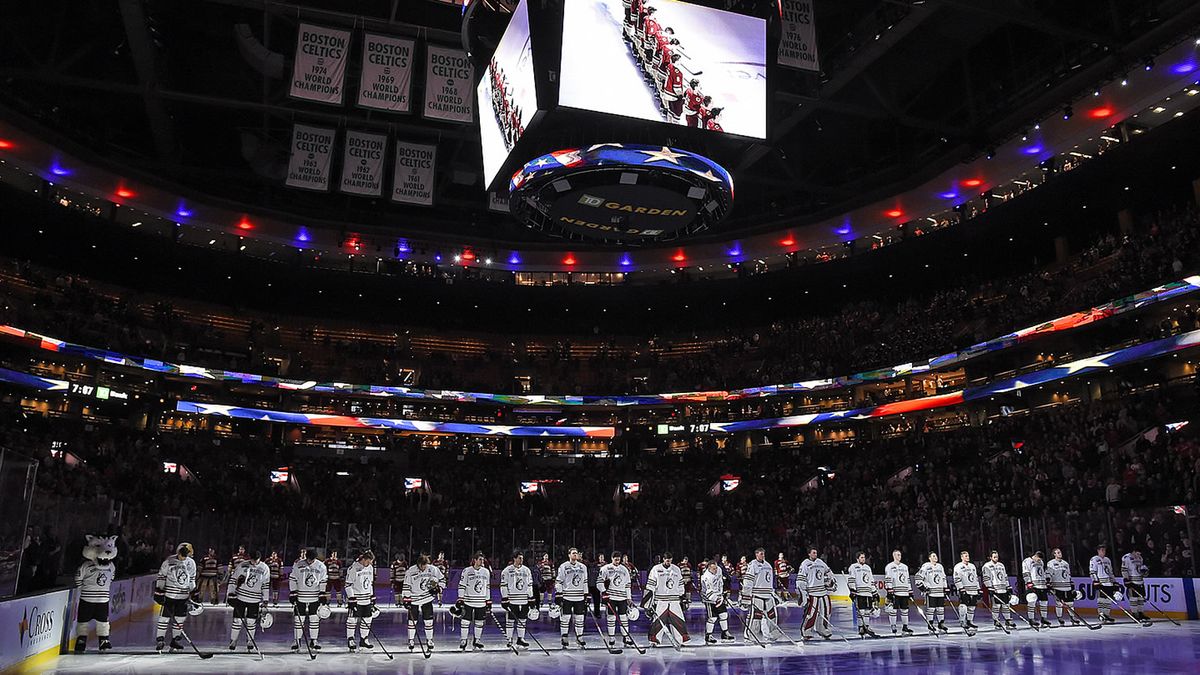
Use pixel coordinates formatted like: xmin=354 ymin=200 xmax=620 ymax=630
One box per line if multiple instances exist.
xmin=623 ymin=0 xmax=724 ymax=131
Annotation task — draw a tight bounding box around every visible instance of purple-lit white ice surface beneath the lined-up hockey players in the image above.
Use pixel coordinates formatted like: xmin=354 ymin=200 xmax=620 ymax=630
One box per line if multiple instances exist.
xmin=46 ymin=604 xmax=1200 ymax=675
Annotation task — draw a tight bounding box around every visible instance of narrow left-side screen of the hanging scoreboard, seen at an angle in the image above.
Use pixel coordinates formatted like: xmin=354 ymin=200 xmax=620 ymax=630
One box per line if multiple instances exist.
xmin=476 ymin=2 xmax=538 ymax=184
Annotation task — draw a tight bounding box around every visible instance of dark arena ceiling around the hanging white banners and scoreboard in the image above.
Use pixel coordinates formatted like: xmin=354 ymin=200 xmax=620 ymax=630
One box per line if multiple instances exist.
xmin=0 ymin=0 xmax=1200 ymax=247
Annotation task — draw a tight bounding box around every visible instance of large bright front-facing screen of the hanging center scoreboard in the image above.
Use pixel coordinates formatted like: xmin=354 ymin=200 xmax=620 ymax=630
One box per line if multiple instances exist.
xmin=556 ymin=0 xmax=767 ymax=138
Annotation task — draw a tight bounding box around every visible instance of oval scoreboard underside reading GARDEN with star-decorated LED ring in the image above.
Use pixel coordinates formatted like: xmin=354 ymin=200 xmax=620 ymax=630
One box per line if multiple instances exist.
xmin=509 ymin=143 xmax=733 ymax=245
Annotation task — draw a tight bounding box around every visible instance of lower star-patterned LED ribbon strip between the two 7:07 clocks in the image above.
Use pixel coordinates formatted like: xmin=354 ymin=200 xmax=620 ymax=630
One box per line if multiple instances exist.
xmin=172 ymin=398 xmax=617 ymax=438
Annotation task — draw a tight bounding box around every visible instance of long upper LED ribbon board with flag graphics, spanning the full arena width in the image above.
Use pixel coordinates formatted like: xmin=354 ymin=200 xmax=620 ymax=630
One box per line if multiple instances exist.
xmin=0 ymin=276 xmax=1200 ymax=407
